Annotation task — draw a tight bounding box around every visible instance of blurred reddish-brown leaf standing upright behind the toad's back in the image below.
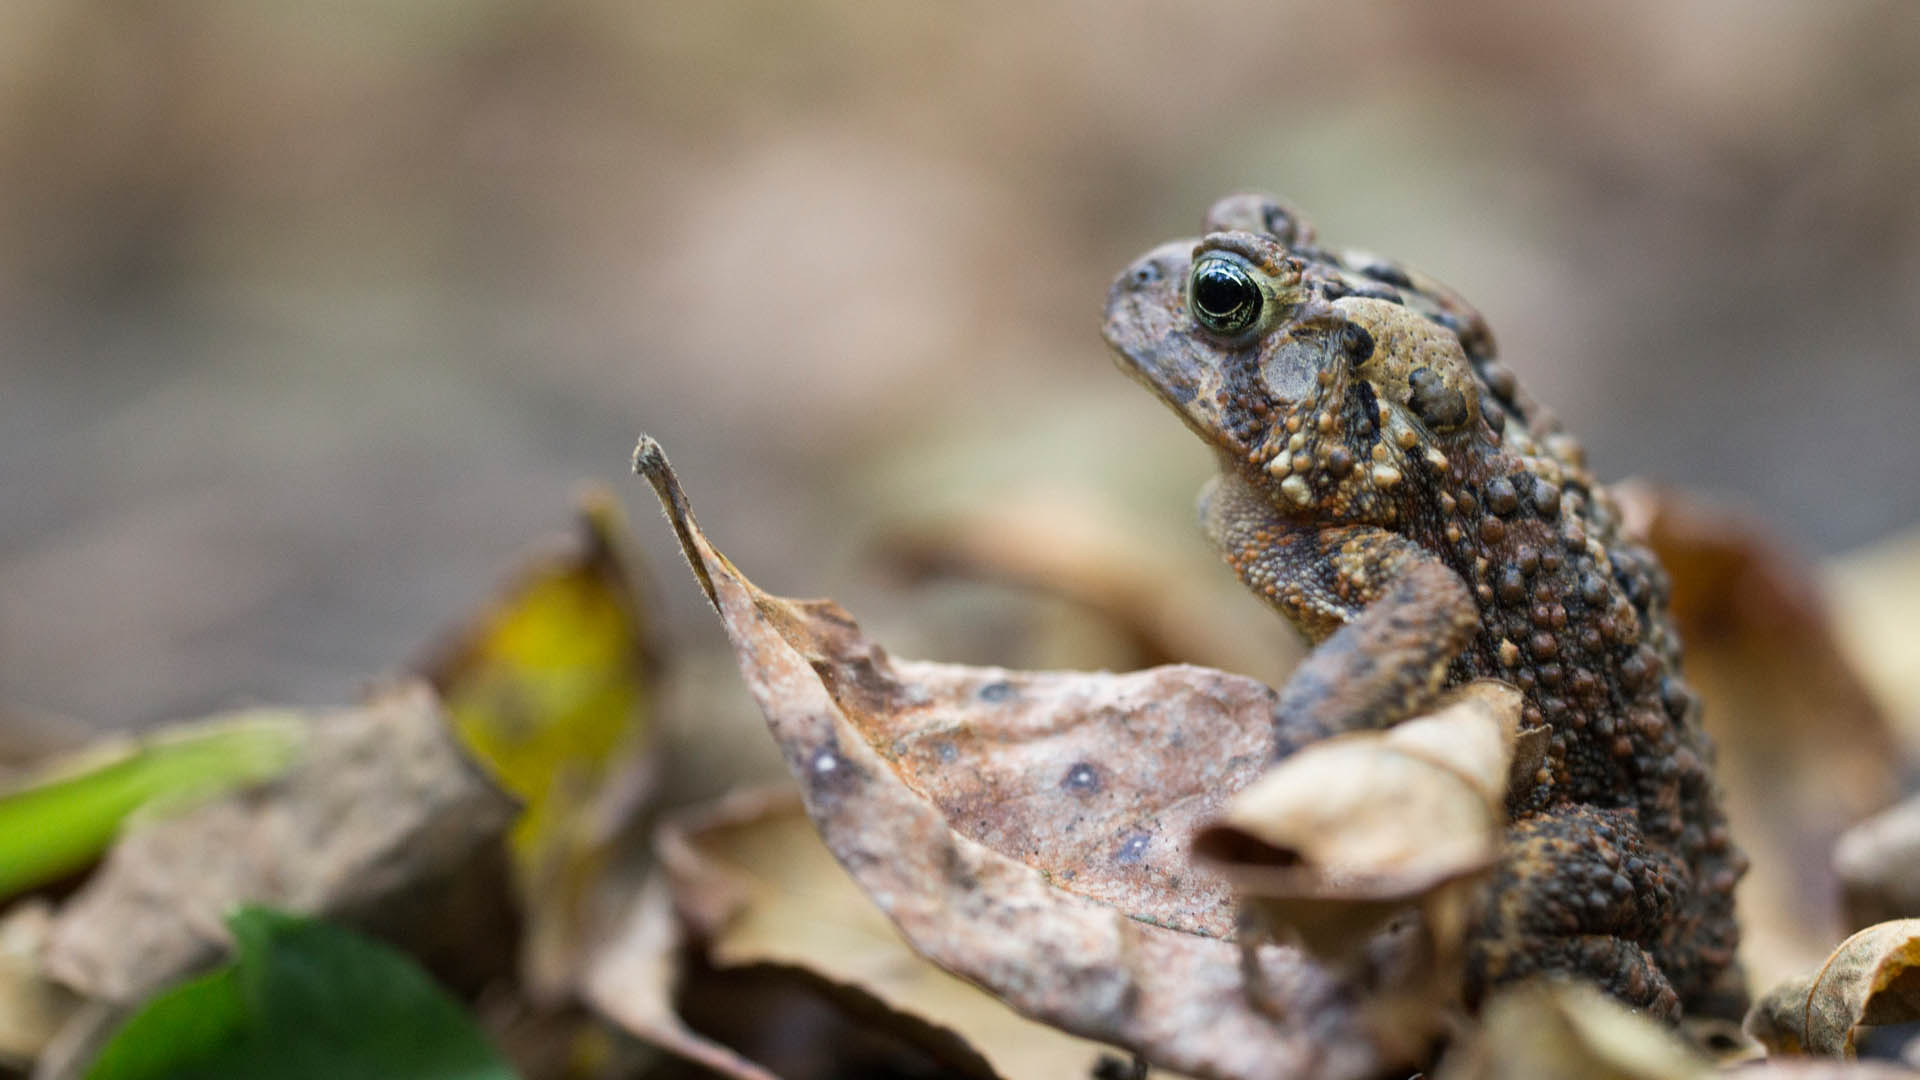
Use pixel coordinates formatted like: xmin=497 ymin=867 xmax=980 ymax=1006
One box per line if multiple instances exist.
xmin=1620 ymin=486 xmax=1901 ymax=986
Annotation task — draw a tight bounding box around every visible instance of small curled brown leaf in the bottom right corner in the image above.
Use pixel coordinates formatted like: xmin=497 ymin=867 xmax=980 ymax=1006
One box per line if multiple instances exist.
xmin=1745 ymin=919 xmax=1920 ymax=1057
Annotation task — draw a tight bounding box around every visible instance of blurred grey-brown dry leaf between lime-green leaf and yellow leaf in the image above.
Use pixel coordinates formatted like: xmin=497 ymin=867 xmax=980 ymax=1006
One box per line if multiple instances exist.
xmin=44 ymin=684 xmax=516 ymax=1003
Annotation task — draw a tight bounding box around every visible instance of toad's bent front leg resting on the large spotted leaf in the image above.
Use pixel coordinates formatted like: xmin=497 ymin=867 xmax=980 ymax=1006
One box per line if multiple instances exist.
xmin=1200 ymin=475 xmax=1480 ymax=757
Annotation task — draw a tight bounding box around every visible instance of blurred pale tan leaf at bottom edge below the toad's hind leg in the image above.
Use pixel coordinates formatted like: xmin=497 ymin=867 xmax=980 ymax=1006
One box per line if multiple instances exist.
xmin=1440 ymin=980 xmax=1713 ymax=1080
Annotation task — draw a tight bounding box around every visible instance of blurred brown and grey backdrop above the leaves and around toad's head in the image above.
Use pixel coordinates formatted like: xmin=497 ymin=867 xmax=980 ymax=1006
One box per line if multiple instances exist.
xmin=0 ymin=0 xmax=1920 ymax=730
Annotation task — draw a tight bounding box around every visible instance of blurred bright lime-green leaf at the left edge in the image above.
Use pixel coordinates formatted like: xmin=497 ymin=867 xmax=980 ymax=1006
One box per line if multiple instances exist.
xmin=0 ymin=711 xmax=305 ymax=899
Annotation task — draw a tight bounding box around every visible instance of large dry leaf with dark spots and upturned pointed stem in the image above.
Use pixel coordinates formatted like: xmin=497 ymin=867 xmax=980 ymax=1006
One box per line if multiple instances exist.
xmin=634 ymin=440 xmax=1392 ymax=1078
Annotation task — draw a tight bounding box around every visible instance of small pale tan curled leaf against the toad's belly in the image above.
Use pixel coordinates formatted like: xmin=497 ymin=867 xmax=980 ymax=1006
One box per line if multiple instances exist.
xmin=1196 ymin=682 xmax=1521 ymax=959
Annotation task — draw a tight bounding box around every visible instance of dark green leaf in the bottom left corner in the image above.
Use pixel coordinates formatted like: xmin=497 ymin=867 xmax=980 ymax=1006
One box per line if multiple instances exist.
xmin=86 ymin=907 xmax=515 ymax=1080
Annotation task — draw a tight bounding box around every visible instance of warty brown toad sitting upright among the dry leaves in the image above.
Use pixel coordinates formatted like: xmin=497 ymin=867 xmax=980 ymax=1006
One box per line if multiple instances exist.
xmin=1106 ymin=194 xmax=1745 ymax=1019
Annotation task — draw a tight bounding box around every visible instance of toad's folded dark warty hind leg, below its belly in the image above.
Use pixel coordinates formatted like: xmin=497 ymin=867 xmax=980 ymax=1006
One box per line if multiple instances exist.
xmin=1467 ymin=805 xmax=1686 ymax=1020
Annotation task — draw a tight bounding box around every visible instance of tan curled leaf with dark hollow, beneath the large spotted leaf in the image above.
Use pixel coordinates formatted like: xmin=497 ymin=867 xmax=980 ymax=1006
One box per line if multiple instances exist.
xmin=588 ymin=788 xmax=1167 ymax=1078
